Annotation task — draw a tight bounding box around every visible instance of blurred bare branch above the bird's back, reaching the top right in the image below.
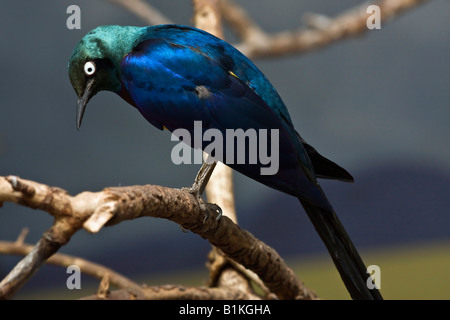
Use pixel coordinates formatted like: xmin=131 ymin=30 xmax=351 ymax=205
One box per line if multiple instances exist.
xmin=219 ymin=0 xmax=430 ymax=58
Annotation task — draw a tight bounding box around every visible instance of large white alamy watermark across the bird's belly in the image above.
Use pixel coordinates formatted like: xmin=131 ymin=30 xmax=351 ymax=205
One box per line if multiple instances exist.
xmin=170 ymin=121 xmax=280 ymax=175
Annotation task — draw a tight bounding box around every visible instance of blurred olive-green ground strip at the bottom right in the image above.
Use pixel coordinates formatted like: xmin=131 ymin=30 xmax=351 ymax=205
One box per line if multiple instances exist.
xmin=292 ymin=242 xmax=450 ymax=300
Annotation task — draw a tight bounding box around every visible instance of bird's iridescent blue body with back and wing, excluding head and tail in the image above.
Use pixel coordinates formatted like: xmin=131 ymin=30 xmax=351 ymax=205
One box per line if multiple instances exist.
xmin=121 ymin=27 xmax=338 ymax=206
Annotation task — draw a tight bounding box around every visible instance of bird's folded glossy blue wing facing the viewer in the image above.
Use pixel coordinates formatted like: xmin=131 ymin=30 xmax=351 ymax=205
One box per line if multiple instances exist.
xmin=121 ymin=39 xmax=326 ymax=194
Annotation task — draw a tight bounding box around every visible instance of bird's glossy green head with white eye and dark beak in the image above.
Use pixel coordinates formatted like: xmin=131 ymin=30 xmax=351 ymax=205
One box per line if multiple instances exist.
xmin=69 ymin=26 xmax=143 ymax=129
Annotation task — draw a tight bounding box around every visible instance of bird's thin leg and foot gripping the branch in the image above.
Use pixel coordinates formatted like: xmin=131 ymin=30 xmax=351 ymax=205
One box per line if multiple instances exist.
xmin=184 ymin=159 xmax=222 ymax=221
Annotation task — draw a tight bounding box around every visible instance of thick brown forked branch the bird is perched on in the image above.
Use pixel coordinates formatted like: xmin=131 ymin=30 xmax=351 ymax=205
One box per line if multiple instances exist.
xmin=0 ymin=176 xmax=315 ymax=299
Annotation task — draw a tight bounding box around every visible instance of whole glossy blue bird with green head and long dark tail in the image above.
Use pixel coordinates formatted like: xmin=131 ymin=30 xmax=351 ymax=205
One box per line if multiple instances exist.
xmin=68 ymin=24 xmax=383 ymax=300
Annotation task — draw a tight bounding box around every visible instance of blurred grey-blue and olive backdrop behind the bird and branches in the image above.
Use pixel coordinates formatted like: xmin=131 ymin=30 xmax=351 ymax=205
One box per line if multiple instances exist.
xmin=0 ymin=0 xmax=450 ymax=299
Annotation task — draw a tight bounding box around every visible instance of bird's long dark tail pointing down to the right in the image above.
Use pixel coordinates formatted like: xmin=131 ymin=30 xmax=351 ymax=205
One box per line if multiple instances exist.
xmin=300 ymin=199 xmax=383 ymax=300
